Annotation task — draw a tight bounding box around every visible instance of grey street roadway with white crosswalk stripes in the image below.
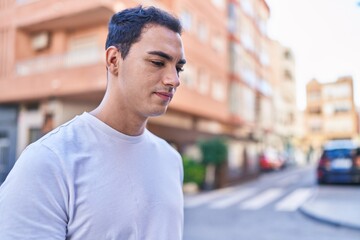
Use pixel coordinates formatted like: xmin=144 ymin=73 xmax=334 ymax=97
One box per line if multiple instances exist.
xmin=184 ymin=166 xmax=360 ymax=240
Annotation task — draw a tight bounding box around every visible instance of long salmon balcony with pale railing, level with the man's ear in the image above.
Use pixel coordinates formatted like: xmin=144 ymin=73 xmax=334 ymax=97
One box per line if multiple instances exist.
xmin=0 ymin=48 xmax=106 ymax=102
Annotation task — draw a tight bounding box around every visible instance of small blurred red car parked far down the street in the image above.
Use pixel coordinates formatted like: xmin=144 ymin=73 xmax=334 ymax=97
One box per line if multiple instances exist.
xmin=259 ymin=148 xmax=285 ymax=171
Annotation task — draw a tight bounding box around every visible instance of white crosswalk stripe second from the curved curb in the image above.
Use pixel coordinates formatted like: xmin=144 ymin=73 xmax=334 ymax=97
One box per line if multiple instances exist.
xmin=240 ymin=188 xmax=284 ymax=210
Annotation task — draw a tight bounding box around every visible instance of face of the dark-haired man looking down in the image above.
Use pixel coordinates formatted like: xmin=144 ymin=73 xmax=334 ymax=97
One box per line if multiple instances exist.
xmin=118 ymin=25 xmax=185 ymax=118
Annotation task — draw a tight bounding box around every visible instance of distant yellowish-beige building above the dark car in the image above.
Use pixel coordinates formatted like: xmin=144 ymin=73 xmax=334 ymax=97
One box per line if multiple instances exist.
xmin=305 ymin=77 xmax=358 ymax=148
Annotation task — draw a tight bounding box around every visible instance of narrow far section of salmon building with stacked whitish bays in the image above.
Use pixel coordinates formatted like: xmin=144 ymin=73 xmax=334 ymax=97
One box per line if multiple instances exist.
xmin=228 ymin=0 xmax=273 ymax=181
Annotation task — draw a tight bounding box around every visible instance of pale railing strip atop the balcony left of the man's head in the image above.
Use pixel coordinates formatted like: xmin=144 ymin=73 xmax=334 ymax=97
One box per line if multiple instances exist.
xmin=16 ymin=48 xmax=103 ymax=76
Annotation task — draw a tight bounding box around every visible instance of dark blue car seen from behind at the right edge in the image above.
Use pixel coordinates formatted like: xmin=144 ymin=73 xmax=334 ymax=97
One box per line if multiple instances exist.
xmin=317 ymin=140 xmax=360 ymax=184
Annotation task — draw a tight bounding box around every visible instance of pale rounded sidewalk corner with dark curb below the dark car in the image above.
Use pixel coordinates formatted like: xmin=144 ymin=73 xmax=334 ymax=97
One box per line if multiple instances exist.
xmin=300 ymin=185 xmax=360 ymax=230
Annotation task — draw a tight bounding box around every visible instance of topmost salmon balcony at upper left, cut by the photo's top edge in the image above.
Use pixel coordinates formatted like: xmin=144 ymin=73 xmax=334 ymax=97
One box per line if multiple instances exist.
xmin=16 ymin=0 xmax=114 ymax=32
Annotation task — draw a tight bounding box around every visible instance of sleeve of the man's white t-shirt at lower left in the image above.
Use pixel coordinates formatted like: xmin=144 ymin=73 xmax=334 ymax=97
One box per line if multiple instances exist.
xmin=0 ymin=143 xmax=69 ymax=240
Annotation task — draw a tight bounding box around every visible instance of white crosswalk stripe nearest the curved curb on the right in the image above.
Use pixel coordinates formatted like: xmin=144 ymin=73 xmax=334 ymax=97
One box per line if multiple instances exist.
xmin=275 ymin=188 xmax=312 ymax=211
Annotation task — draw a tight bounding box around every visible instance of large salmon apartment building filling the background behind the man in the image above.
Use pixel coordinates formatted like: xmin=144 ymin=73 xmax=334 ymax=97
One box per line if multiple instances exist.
xmin=0 ymin=0 xmax=291 ymax=185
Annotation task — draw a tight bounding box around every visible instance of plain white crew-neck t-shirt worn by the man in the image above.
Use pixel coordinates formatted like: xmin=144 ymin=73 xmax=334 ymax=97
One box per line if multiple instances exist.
xmin=0 ymin=113 xmax=183 ymax=240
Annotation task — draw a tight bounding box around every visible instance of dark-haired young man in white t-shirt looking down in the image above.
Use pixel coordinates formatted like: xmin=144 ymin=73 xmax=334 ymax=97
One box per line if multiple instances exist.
xmin=0 ymin=7 xmax=185 ymax=240
